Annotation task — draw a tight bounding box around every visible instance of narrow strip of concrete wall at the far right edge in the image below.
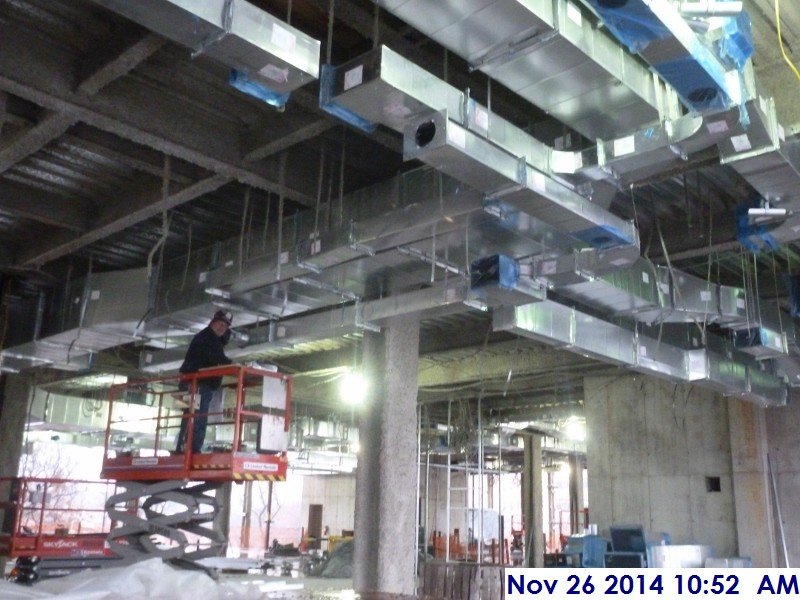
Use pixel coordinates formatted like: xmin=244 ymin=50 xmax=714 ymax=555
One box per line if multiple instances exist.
xmin=765 ymin=402 xmax=800 ymax=567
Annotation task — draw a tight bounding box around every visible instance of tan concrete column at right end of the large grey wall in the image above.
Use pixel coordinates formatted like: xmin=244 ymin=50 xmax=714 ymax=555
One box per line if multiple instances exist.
xmin=728 ymin=399 xmax=781 ymax=567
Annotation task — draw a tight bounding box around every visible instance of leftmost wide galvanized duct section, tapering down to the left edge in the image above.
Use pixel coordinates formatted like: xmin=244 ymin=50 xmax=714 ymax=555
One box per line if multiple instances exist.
xmin=0 ymin=268 xmax=149 ymax=371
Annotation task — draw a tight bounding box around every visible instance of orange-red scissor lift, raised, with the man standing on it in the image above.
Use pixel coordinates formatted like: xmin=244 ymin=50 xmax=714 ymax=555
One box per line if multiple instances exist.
xmin=101 ymin=365 xmax=292 ymax=561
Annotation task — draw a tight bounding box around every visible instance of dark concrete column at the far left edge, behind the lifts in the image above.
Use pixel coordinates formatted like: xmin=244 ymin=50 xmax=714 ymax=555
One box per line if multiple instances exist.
xmin=0 ymin=374 xmax=32 ymax=477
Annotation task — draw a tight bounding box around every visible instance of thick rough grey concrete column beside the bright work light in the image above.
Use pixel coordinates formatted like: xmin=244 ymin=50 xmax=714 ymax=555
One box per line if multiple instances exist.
xmin=353 ymin=315 xmax=419 ymax=595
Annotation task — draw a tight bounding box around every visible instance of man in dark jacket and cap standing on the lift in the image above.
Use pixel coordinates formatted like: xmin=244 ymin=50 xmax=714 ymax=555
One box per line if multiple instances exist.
xmin=175 ymin=310 xmax=233 ymax=454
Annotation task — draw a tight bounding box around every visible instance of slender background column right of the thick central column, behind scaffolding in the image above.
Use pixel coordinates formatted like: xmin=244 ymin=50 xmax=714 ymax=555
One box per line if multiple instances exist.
xmin=522 ymin=435 xmax=544 ymax=567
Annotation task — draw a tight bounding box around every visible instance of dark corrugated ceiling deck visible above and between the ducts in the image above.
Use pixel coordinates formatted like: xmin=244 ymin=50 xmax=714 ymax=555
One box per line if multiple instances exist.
xmin=0 ymin=0 xmax=800 ymax=432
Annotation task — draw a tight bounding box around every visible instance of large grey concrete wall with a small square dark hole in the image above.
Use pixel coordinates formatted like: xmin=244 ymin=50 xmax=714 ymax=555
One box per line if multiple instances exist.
xmin=584 ymin=374 xmax=736 ymax=556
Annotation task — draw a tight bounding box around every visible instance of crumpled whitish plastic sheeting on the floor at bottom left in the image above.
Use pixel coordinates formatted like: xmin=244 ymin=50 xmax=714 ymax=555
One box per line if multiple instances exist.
xmin=0 ymin=558 xmax=300 ymax=600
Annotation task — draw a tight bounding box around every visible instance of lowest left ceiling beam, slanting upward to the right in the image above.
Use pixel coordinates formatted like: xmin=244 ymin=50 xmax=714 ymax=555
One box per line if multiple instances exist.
xmin=16 ymin=175 xmax=230 ymax=267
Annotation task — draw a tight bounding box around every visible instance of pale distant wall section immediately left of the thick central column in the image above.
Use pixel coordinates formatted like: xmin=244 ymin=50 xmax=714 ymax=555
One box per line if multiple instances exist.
xmin=300 ymin=475 xmax=356 ymax=535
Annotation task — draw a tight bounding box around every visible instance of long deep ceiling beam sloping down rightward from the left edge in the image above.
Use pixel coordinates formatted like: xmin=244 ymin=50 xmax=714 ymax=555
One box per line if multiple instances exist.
xmin=0 ymin=31 xmax=314 ymax=206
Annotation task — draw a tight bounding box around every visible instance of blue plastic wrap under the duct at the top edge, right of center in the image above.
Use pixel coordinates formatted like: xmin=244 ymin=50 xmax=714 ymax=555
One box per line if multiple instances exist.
xmin=588 ymin=0 xmax=672 ymax=52
